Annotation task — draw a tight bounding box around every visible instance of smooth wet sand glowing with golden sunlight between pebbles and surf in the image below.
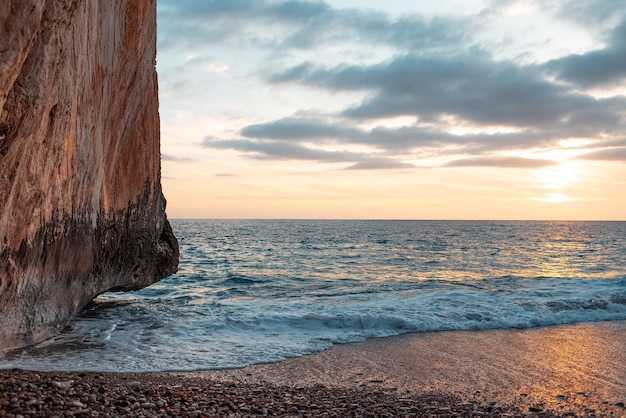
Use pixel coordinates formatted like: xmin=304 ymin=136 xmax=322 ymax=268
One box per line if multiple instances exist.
xmin=191 ymin=321 xmax=626 ymax=416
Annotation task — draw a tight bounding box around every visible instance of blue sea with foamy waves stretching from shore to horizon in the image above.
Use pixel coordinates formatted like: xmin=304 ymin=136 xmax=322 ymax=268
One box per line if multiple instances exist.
xmin=0 ymin=220 xmax=626 ymax=372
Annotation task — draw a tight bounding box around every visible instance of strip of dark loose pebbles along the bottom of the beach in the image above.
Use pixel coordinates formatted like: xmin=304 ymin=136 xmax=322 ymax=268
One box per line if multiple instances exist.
xmin=0 ymin=370 xmax=557 ymax=417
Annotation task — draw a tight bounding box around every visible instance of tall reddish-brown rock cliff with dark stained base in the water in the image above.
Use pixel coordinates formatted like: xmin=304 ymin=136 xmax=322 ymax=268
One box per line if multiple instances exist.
xmin=0 ymin=0 xmax=178 ymax=349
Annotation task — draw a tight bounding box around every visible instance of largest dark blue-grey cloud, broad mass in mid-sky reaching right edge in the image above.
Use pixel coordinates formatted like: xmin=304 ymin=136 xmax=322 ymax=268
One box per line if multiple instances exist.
xmin=269 ymin=51 xmax=626 ymax=129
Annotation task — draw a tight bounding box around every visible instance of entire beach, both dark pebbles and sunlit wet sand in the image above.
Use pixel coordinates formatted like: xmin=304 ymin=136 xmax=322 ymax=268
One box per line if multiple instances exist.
xmin=0 ymin=321 xmax=626 ymax=417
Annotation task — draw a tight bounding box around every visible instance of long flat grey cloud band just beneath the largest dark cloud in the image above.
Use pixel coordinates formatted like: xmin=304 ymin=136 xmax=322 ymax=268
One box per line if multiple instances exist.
xmin=201 ymin=118 xmax=572 ymax=170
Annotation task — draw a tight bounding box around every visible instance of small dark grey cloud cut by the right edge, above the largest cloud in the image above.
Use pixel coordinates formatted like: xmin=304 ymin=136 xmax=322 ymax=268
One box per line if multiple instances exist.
xmin=545 ymin=20 xmax=626 ymax=88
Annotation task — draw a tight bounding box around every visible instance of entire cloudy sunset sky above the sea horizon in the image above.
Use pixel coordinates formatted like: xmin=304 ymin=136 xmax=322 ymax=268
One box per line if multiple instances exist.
xmin=157 ymin=0 xmax=626 ymax=220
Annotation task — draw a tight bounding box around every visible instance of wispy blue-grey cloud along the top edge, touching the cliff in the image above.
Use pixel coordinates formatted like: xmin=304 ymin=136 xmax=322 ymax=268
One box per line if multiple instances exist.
xmin=158 ymin=0 xmax=472 ymax=50
